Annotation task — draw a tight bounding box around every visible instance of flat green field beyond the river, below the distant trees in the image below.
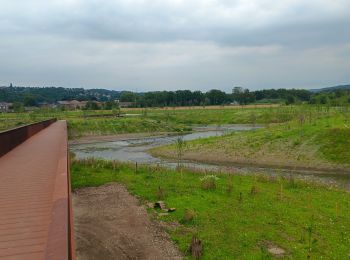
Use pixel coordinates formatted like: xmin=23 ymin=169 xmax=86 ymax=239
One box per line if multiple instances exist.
xmin=0 ymin=105 xmax=344 ymax=138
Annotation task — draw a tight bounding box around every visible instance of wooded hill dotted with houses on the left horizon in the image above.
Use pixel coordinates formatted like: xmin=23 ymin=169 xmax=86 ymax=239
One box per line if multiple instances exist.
xmin=0 ymin=86 xmax=122 ymax=105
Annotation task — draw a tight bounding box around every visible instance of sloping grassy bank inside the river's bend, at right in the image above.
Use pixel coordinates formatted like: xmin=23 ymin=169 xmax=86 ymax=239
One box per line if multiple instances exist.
xmin=151 ymin=110 xmax=350 ymax=170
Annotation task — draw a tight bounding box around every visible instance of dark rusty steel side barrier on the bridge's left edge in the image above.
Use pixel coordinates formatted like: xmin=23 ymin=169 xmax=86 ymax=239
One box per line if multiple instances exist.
xmin=0 ymin=118 xmax=57 ymax=157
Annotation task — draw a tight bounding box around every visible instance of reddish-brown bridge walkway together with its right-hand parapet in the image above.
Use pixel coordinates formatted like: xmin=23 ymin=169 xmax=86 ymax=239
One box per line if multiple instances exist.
xmin=0 ymin=121 xmax=75 ymax=260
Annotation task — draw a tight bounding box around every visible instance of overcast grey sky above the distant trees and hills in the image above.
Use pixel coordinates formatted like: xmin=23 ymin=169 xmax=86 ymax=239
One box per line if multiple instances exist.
xmin=0 ymin=0 xmax=350 ymax=91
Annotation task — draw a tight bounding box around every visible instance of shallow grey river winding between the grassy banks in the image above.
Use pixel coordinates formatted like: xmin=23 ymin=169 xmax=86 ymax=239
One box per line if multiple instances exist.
xmin=70 ymin=125 xmax=350 ymax=190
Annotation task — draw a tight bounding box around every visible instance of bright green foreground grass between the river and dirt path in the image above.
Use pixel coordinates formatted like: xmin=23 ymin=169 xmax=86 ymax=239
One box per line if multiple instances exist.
xmin=72 ymin=160 xmax=350 ymax=259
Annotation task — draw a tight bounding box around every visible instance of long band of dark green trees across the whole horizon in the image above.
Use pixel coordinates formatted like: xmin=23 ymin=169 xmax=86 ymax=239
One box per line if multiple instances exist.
xmin=0 ymin=86 xmax=350 ymax=108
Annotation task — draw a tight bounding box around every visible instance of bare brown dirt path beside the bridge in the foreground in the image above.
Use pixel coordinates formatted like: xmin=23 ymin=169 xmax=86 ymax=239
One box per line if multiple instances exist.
xmin=73 ymin=183 xmax=182 ymax=260
